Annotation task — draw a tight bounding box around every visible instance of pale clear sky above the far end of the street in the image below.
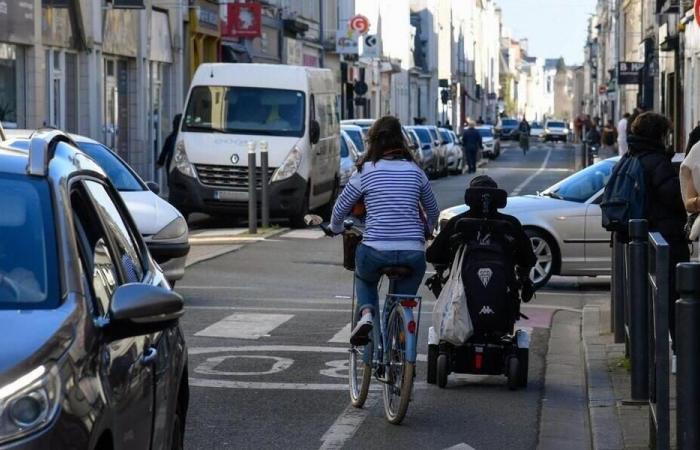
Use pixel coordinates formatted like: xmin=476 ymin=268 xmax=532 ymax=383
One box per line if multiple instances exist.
xmin=496 ymin=0 xmax=596 ymax=65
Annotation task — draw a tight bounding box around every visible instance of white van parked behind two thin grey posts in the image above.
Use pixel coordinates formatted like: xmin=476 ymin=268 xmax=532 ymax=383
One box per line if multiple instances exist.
xmin=168 ymin=63 xmax=340 ymax=227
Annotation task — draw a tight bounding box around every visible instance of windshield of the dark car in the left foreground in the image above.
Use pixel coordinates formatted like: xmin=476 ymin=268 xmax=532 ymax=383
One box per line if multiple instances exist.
xmin=0 ymin=175 xmax=60 ymax=309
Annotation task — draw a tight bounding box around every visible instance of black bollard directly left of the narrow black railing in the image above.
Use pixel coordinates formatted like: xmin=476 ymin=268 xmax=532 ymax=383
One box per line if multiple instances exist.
xmin=627 ymin=220 xmax=649 ymax=400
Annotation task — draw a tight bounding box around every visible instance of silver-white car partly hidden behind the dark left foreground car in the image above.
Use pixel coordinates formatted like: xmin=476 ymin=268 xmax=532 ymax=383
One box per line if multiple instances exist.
xmin=6 ymin=130 xmax=190 ymax=286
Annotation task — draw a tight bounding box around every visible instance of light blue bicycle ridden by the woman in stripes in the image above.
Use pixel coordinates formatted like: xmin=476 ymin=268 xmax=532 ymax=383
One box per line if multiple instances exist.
xmin=307 ymin=215 xmax=422 ymax=425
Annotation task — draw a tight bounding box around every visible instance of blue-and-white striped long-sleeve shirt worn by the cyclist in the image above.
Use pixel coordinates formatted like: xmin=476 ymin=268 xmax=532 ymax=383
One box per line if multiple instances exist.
xmin=331 ymin=160 xmax=440 ymax=251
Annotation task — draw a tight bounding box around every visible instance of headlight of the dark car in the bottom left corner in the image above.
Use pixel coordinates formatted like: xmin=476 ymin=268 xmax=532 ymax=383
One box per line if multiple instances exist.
xmin=0 ymin=366 xmax=61 ymax=444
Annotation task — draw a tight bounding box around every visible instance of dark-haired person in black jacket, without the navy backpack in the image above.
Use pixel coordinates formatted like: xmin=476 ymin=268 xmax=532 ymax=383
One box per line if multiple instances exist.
xmin=628 ymin=112 xmax=690 ymax=348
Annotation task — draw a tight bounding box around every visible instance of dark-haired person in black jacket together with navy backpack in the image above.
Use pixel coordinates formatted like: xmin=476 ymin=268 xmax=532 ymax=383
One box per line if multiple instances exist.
xmin=601 ymin=112 xmax=690 ymax=348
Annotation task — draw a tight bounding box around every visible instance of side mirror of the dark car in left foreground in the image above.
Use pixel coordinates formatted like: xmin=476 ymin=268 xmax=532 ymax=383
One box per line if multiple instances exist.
xmin=106 ymin=283 xmax=185 ymax=340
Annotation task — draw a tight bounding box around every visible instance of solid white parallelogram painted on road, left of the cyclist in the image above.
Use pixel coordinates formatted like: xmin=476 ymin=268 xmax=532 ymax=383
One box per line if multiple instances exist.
xmin=195 ymin=313 xmax=294 ymax=339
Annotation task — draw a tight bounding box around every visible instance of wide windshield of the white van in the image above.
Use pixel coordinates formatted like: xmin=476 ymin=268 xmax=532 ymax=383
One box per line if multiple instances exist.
xmin=182 ymin=86 xmax=305 ymax=137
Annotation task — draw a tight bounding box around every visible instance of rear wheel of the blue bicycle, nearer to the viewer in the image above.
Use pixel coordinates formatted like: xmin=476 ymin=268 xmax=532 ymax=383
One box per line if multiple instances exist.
xmin=384 ymin=306 xmax=416 ymax=425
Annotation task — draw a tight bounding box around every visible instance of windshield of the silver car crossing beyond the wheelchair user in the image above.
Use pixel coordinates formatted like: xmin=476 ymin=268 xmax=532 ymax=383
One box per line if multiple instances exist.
xmin=542 ymin=160 xmax=615 ymax=203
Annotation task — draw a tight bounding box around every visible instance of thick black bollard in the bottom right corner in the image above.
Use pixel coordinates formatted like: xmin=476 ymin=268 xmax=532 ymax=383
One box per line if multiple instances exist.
xmin=676 ymin=263 xmax=700 ymax=450
